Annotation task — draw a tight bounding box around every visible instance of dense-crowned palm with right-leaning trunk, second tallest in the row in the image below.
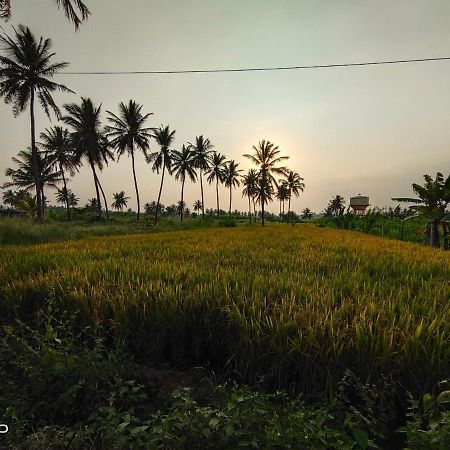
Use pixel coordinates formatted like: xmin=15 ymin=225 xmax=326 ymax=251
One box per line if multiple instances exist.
xmin=63 ymin=98 xmax=113 ymax=219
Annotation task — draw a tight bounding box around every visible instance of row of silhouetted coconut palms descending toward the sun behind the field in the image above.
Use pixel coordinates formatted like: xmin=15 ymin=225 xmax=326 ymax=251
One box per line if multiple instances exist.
xmin=0 ymin=25 xmax=305 ymax=225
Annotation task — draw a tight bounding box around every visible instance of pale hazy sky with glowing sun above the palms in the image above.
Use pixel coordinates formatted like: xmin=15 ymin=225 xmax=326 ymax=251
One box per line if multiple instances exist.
xmin=0 ymin=0 xmax=450 ymax=211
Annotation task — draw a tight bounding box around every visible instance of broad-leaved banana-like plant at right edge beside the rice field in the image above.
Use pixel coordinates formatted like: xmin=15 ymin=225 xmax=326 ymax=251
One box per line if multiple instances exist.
xmin=392 ymin=172 xmax=450 ymax=250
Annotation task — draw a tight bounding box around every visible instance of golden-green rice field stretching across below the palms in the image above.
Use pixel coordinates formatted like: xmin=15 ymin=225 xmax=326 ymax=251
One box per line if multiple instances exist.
xmin=0 ymin=225 xmax=450 ymax=393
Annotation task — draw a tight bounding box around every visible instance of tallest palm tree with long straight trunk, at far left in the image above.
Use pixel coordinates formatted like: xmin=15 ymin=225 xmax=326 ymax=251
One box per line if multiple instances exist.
xmin=0 ymin=25 xmax=73 ymax=220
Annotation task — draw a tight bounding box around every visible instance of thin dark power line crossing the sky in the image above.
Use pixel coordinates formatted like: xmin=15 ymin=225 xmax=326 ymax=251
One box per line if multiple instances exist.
xmin=60 ymin=56 xmax=450 ymax=75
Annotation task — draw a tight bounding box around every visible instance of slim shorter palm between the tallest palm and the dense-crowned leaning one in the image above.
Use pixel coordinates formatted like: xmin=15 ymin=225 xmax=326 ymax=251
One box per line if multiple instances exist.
xmin=40 ymin=126 xmax=76 ymax=220
